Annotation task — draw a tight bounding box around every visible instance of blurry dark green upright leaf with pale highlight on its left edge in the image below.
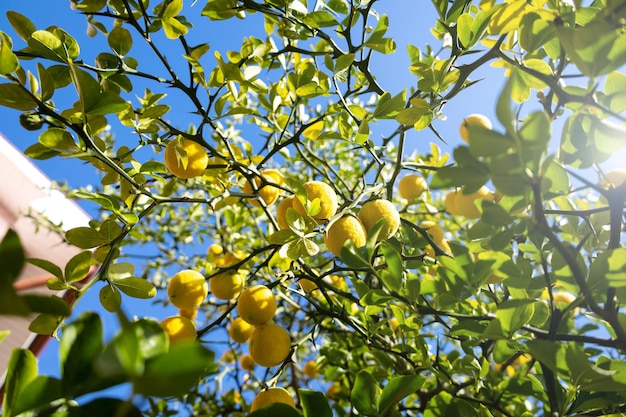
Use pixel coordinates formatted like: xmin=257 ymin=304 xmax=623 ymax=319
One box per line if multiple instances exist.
xmin=59 ymin=312 xmax=102 ymax=396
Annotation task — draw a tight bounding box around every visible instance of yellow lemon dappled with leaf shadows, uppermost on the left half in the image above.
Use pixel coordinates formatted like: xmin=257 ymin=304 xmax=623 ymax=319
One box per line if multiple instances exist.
xmin=163 ymin=139 xmax=209 ymax=178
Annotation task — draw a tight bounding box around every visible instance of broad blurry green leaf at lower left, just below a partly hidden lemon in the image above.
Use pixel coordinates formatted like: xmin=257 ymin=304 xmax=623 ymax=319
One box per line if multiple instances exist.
xmin=133 ymin=342 xmax=216 ymax=397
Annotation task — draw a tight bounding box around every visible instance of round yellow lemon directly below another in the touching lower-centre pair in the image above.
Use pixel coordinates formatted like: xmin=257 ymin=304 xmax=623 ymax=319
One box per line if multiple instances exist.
xmin=248 ymin=323 xmax=291 ymax=368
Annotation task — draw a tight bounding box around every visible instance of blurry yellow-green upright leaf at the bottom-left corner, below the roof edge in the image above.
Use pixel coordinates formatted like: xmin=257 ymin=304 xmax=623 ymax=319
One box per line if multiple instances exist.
xmin=2 ymin=349 xmax=37 ymax=417
